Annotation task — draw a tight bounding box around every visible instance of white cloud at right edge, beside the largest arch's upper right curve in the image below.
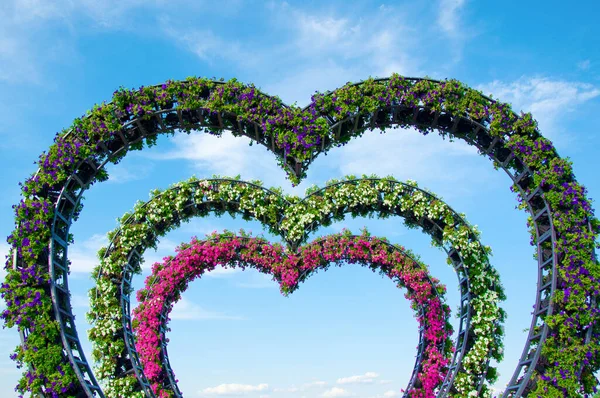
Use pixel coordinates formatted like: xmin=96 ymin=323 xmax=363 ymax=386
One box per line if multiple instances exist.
xmin=477 ymin=77 xmax=600 ymax=140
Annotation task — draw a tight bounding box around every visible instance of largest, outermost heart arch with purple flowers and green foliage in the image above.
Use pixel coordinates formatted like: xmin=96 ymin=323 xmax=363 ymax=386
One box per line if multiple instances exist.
xmin=1 ymin=75 xmax=600 ymax=397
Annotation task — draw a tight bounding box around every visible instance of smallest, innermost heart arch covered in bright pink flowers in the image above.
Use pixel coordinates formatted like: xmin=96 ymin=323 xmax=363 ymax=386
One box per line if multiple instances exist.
xmin=133 ymin=231 xmax=453 ymax=398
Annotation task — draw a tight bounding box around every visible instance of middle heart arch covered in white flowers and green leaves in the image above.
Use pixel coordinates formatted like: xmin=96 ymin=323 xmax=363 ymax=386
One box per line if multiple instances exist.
xmin=89 ymin=176 xmax=505 ymax=397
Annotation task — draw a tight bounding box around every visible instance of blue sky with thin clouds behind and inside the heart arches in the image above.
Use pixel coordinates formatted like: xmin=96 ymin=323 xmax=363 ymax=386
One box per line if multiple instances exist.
xmin=0 ymin=0 xmax=600 ymax=398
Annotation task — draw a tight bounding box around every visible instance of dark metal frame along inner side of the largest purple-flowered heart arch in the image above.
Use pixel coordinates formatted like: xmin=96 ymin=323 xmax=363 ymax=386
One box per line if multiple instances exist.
xmin=13 ymin=78 xmax=593 ymax=398
